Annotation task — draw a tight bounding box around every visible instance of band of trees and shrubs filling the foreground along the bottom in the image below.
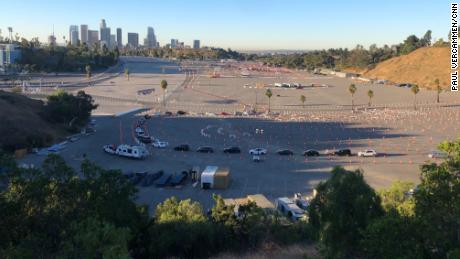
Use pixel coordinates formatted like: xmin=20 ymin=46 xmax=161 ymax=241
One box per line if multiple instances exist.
xmin=0 ymin=137 xmax=460 ymax=258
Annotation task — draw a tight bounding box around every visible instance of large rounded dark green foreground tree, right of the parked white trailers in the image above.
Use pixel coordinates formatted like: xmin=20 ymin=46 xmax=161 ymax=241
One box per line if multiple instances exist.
xmin=308 ymin=167 xmax=383 ymax=258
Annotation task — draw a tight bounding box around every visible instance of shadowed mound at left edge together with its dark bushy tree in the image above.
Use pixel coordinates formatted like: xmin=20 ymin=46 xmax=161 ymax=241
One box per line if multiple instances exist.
xmin=0 ymin=91 xmax=96 ymax=152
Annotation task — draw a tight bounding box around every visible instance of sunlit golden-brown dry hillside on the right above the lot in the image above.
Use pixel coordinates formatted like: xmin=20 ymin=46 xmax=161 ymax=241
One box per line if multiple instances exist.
xmin=363 ymin=47 xmax=450 ymax=88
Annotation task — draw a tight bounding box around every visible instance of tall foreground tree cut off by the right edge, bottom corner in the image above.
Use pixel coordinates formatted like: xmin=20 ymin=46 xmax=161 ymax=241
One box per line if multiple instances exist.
xmin=414 ymin=137 xmax=460 ymax=258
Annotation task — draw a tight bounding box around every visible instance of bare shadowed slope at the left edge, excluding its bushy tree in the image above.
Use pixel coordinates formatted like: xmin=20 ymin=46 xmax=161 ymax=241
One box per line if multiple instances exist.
xmin=0 ymin=91 xmax=66 ymax=151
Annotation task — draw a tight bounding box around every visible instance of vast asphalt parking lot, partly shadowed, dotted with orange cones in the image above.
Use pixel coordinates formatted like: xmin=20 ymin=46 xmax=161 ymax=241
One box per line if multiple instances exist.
xmin=20 ymin=57 xmax=460 ymax=209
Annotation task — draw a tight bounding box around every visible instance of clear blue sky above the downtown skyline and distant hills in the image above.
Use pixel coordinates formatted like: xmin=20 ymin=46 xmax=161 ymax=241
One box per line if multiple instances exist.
xmin=0 ymin=0 xmax=450 ymax=50
